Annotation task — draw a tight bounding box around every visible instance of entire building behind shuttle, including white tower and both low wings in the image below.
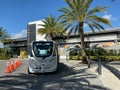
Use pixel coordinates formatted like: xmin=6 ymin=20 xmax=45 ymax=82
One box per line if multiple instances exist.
xmin=4 ymin=20 xmax=120 ymax=57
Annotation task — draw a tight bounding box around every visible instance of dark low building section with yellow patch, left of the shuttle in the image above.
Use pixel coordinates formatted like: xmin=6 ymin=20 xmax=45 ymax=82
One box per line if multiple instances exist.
xmin=4 ymin=38 xmax=27 ymax=57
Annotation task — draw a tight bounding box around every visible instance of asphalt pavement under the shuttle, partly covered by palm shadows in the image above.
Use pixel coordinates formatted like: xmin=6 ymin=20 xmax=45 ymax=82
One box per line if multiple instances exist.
xmin=0 ymin=60 xmax=120 ymax=90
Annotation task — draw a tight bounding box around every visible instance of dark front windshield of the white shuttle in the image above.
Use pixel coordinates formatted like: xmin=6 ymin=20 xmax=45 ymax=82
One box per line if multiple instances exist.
xmin=33 ymin=42 xmax=53 ymax=57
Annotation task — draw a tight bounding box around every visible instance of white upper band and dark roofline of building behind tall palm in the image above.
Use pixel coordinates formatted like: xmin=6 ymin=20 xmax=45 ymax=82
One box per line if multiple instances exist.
xmin=54 ymin=28 xmax=120 ymax=47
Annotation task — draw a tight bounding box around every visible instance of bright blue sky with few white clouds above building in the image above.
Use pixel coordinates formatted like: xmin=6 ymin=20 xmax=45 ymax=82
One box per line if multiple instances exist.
xmin=0 ymin=0 xmax=120 ymax=38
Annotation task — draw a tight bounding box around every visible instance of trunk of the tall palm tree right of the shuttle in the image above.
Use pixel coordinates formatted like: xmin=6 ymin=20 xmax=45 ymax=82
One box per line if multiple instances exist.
xmin=79 ymin=22 xmax=88 ymax=63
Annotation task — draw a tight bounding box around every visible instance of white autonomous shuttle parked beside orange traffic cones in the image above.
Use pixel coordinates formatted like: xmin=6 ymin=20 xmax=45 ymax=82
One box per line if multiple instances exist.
xmin=28 ymin=41 xmax=59 ymax=74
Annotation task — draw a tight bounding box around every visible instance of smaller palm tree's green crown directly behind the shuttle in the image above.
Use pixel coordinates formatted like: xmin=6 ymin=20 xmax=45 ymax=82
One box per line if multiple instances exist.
xmin=38 ymin=15 xmax=64 ymax=39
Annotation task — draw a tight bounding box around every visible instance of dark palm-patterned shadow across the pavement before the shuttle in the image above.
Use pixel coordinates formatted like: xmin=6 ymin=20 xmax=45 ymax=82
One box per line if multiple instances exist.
xmin=0 ymin=63 xmax=108 ymax=90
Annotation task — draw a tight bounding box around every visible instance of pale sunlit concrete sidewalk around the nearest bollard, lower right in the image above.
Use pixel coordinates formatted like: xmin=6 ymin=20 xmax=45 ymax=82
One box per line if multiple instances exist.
xmin=89 ymin=63 xmax=120 ymax=90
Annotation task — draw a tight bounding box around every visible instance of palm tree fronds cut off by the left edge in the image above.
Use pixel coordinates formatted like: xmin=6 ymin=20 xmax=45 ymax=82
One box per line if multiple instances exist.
xmin=0 ymin=27 xmax=10 ymax=43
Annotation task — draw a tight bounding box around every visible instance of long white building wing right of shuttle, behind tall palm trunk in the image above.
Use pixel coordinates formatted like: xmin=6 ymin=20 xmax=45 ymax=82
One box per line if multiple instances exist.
xmin=54 ymin=28 xmax=120 ymax=58
